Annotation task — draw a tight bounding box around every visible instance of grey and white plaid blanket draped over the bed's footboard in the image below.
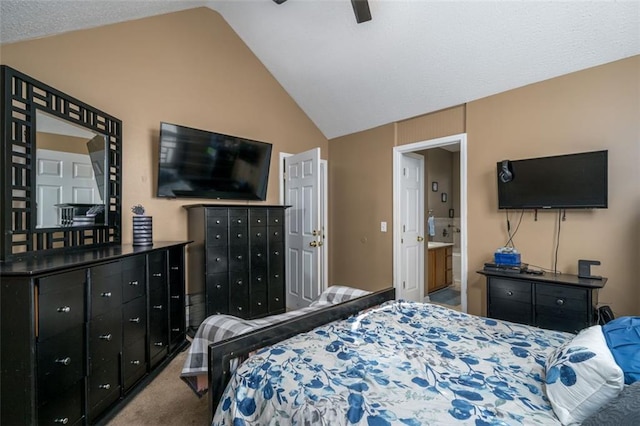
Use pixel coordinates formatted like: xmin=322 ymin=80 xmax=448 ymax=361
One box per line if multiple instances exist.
xmin=180 ymin=285 xmax=370 ymax=396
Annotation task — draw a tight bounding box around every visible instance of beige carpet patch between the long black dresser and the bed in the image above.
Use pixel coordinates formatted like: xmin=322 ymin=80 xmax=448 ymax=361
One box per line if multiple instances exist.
xmin=107 ymin=350 xmax=209 ymax=426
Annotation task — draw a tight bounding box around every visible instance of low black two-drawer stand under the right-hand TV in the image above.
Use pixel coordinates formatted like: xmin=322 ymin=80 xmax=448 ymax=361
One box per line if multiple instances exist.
xmin=477 ymin=270 xmax=607 ymax=333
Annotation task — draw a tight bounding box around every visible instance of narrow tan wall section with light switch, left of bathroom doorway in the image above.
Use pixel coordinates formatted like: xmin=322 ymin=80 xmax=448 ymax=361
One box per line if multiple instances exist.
xmin=329 ymin=121 xmax=395 ymax=290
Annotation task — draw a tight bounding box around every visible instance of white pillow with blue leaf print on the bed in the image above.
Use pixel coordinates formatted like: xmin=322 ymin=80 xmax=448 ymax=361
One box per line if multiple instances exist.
xmin=545 ymin=325 xmax=624 ymax=425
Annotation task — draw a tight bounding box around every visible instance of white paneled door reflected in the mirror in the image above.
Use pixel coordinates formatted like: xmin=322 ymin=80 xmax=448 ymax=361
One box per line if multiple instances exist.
xmin=36 ymin=149 xmax=102 ymax=228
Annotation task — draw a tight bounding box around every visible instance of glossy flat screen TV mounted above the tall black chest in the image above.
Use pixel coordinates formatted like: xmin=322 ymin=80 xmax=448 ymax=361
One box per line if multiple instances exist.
xmin=157 ymin=122 xmax=272 ymax=200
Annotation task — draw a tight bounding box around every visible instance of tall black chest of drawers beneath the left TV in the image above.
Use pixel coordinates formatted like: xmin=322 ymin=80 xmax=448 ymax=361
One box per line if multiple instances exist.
xmin=185 ymin=204 xmax=285 ymax=326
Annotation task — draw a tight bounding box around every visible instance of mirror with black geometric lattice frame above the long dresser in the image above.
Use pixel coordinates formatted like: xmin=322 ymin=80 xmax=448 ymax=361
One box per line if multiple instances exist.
xmin=0 ymin=65 xmax=122 ymax=260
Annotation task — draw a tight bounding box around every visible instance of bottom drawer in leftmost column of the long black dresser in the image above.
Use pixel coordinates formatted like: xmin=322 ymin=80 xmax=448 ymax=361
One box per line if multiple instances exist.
xmin=38 ymin=380 xmax=84 ymax=426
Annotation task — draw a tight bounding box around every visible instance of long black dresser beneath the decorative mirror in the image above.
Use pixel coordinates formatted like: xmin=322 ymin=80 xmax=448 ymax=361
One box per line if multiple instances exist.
xmin=0 ymin=242 xmax=187 ymax=425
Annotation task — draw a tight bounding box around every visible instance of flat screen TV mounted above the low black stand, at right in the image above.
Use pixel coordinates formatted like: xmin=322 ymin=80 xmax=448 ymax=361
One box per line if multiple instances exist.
xmin=497 ymin=150 xmax=608 ymax=209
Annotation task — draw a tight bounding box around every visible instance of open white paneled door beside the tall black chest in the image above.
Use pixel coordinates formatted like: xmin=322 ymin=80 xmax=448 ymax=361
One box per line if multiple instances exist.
xmin=284 ymin=148 xmax=324 ymax=309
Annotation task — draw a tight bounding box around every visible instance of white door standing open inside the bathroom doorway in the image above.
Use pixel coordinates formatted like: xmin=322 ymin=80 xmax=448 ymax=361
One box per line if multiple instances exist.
xmin=396 ymin=154 xmax=424 ymax=302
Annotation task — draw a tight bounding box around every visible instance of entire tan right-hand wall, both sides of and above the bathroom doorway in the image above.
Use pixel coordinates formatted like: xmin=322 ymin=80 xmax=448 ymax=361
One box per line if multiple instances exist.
xmin=329 ymin=56 xmax=640 ymax=315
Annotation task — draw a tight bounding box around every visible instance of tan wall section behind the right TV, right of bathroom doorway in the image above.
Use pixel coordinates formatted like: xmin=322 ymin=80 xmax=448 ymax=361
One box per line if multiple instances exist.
xmin=467 ymin=56 xmax=640 ymax=315
